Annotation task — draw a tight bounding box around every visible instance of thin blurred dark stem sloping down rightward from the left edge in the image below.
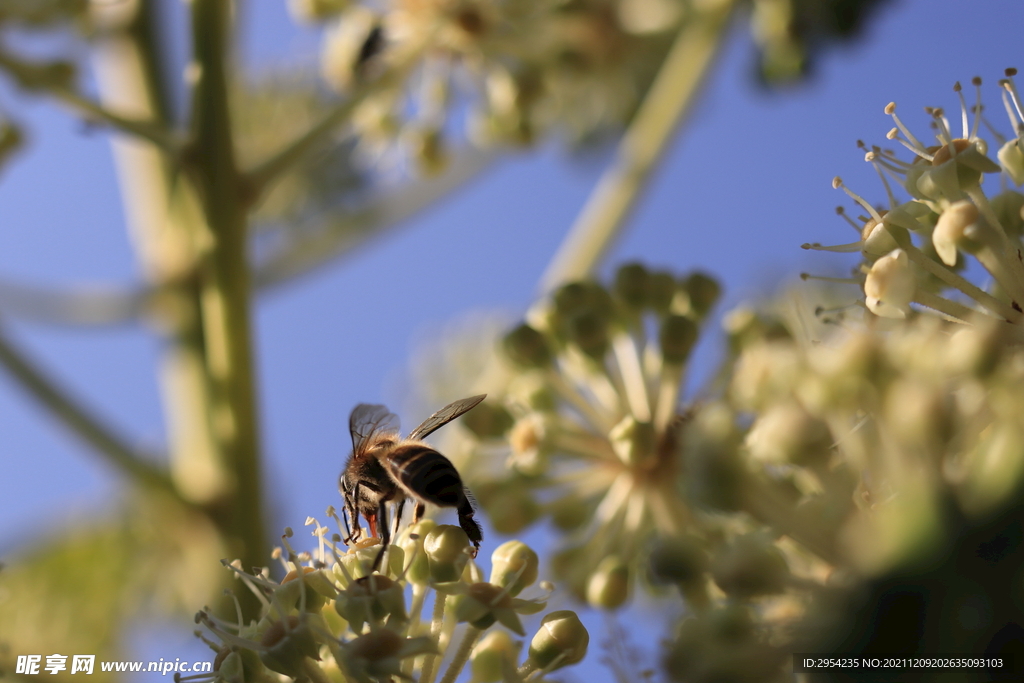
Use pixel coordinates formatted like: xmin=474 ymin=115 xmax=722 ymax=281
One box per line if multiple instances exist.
xmin=0 ymin=321 xmax=180 ymax=500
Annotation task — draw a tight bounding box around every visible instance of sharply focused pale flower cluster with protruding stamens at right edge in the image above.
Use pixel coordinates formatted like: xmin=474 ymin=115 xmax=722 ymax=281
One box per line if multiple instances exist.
xmin=804 ymin=69 xmax=1024 ymax=326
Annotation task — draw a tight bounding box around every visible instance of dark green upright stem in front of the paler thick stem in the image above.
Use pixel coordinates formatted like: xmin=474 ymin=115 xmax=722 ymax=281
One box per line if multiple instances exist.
xmin=184 ymin=0 xmax=267 ymax=618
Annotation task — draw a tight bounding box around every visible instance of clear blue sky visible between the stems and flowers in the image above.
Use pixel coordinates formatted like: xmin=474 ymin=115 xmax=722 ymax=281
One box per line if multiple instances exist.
xmin=0 ymin=0 xmax=1024 ymax=679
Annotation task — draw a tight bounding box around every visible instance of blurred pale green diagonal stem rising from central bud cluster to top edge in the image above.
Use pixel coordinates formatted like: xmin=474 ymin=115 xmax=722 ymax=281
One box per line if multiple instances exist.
xmin=540 ymin=2 xmax=733 ymax=292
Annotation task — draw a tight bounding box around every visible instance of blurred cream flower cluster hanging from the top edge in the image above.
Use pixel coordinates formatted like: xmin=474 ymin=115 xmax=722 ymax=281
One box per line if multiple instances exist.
xmin=292 ymin=0 xmax=695 ymax=171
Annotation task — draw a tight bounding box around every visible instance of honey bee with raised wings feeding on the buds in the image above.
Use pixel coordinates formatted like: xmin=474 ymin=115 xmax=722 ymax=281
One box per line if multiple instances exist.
xmin=338 ymin=394 xmax=486 ymax=570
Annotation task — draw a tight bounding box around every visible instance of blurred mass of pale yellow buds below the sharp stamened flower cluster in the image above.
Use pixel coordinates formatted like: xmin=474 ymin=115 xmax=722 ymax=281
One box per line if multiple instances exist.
xmin=730 ymin=312 xmax=1024 ymax=574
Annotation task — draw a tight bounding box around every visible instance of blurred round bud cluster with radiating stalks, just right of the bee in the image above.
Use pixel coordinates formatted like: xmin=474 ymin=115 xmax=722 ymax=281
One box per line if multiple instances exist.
xmin=456 ymin=263 xmax=719 ymax=608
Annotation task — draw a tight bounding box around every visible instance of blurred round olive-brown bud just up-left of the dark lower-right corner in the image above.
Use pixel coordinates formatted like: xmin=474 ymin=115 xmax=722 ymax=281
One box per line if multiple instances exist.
xmin=711 ymin=533 xmax=790 ymax=598
